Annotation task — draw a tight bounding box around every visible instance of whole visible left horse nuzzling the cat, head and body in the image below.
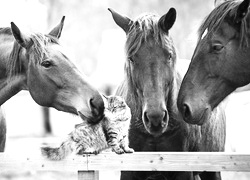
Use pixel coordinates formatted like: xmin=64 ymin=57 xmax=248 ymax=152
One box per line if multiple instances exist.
xmin=0 ymin=17 xmax=104 ymax=152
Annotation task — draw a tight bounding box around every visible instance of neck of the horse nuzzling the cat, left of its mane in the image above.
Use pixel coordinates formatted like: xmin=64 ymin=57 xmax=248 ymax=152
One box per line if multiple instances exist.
xmin=0 ymin=34 xmax=26 ymax=106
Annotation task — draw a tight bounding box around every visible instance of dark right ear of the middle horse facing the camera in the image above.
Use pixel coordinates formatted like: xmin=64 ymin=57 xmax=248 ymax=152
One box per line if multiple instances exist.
xmin=158 ymin=8 xmax=176 ymax=33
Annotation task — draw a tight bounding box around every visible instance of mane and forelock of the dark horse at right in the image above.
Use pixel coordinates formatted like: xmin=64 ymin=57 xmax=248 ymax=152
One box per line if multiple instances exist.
xmin=198 ymin=0 xmax=248 ymax=46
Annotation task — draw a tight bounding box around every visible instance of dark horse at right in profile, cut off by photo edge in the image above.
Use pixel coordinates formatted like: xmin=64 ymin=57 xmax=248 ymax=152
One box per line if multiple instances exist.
xmin=177 ymin=0 xmax=250 ymax=124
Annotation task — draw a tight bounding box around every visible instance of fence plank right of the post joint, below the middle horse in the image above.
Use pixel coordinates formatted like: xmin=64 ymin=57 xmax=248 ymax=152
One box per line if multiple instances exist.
xmin=88 ymin=152 xmax=250 ymax=171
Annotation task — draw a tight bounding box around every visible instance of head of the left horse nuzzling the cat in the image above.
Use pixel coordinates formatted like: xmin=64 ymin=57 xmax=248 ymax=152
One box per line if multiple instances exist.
xmin=10 ymin=17 xmax=104 ymax=122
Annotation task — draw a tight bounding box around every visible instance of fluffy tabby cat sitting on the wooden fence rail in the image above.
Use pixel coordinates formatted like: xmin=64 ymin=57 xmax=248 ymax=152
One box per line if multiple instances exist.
xmin=41 ymin=96 xmax=134 ymax=160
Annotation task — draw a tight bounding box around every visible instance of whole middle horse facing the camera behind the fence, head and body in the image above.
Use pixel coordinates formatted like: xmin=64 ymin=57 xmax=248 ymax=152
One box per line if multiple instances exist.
xmin=109 ymin=8 xmax=225 ymax=180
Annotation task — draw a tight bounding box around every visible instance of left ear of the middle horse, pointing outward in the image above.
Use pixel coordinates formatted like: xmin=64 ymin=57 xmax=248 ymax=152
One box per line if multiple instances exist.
xmin=108 ymin=8 xmax=133 ymax=34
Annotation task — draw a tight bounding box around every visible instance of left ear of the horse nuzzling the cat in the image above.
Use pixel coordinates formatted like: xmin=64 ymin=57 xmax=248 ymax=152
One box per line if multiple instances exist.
xmin=10 ymin=22 xmax=32 ymax=49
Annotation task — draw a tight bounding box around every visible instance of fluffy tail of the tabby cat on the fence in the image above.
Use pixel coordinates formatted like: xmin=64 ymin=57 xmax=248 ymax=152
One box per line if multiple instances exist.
xmin=41 ymin=140 xmax=73 ymax=161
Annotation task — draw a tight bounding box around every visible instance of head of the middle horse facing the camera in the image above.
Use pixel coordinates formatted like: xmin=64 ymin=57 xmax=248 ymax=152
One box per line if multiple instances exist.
xmin=109 ymin=8 xmax=176 ymax=136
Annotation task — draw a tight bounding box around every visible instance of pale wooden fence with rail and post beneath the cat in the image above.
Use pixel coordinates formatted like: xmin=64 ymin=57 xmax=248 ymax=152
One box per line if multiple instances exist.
xmin=0 ymin=152 xmax=250 ymax=180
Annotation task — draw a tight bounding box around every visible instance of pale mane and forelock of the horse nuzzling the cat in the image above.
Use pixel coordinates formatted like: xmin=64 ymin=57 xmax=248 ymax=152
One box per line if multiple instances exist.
xmin=7 ymin=28 xmax=59 ymax=80
